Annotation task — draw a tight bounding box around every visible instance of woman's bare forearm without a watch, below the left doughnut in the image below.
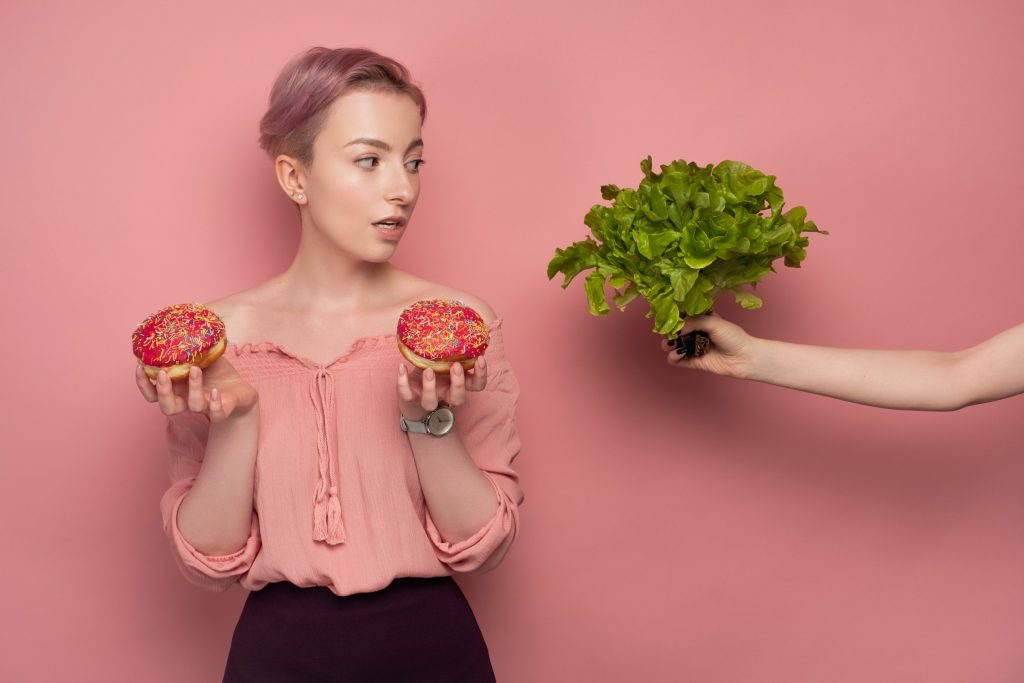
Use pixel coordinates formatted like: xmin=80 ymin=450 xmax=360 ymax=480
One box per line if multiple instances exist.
xmin=178 ymin=407 xmax=259 ymax=555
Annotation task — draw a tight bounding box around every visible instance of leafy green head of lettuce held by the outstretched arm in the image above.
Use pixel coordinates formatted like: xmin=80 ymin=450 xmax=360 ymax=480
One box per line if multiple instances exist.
xmin=548 ymin=157 xmax=827 ymax=337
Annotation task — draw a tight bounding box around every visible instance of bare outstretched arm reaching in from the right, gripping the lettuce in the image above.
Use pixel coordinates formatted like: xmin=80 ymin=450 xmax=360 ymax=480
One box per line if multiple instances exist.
xmin=662 ymin=315 xmax=1024 ymax=411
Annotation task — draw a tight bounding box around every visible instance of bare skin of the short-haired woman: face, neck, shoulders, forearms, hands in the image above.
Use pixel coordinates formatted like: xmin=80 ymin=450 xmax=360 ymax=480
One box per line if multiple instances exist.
xmin=136 ymin=90 xmax=498 ymax=555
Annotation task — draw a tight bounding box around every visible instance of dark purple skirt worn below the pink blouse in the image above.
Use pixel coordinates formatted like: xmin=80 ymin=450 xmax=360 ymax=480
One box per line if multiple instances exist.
xmin=224 ymin=577 xmax=495 ymax=683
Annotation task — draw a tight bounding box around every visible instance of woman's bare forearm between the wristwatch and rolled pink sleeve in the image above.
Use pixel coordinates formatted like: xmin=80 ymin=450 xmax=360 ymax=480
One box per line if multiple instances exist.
xmin=409 ymin=430 xmax=498 ymax=543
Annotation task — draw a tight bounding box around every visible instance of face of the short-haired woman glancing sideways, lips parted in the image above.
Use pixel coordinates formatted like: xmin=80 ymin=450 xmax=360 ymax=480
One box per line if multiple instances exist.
xmin=303 ymin=90 xmax=423 ymax=262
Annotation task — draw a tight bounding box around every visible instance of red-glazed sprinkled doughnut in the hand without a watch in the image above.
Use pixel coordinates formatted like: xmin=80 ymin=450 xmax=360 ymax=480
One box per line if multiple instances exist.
xmin=131 ymin=303 xmax=227 ymax=381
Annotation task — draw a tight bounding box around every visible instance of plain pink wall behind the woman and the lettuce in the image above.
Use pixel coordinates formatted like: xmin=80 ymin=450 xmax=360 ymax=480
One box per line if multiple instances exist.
xmin=0 ymin=0 xmax=1024 ymax=683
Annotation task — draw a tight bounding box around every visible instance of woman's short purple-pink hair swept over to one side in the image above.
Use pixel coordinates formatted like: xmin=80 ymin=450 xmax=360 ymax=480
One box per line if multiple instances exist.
xmin=259 ymin=47 xmax=427 ymax=166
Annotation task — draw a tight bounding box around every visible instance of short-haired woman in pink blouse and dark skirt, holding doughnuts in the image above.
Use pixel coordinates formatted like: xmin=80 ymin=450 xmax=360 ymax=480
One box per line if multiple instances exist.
xmin=136 ymin=48 xmax=522 ymax=683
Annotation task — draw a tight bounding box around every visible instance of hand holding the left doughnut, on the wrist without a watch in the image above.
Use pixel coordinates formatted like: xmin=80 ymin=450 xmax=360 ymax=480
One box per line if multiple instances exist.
xmin=135 ymin=356 xmax=258 ymax=423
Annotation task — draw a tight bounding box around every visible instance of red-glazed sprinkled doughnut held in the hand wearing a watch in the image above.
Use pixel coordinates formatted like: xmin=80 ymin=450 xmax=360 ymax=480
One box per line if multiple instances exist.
xmin=398 ymin=299 xmax=490 ymax=373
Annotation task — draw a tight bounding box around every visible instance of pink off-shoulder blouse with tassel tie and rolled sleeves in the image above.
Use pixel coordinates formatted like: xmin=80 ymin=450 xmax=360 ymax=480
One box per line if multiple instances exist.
xmin=161 ymin=321 xmax=522 ymax=595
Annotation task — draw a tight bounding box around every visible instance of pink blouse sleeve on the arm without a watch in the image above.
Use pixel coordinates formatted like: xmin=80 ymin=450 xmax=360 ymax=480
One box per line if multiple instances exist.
xmin=160 ymin=413 xmax=260 ymax=591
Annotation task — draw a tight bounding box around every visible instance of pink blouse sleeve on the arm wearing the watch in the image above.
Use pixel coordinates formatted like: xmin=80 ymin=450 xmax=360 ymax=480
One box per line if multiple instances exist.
xmin=426 ymin=339 xmax=523 ymax=573
